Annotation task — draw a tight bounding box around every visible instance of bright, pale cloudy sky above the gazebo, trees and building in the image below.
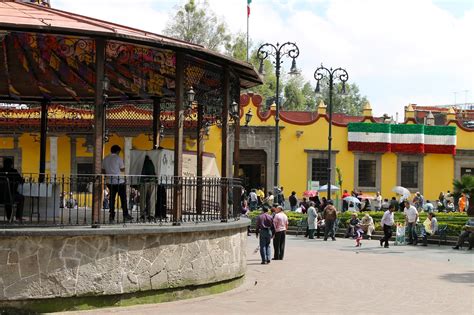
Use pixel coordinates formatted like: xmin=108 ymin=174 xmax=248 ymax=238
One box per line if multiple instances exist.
xmin=51 ymin=0 xmax=474 ymax=117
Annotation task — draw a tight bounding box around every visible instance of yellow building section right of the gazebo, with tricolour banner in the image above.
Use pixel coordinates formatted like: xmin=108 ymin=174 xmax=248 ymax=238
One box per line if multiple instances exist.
xmin=231 ymin=94 xmax=474 ymax=200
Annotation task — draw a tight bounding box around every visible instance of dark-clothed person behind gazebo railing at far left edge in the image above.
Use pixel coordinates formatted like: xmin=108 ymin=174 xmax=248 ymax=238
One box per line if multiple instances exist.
xmin=0 ymin=158 xmax=25 ymax=223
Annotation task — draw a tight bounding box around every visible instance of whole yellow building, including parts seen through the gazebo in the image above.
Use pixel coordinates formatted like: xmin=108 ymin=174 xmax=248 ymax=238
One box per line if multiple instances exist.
xmin=0 ymin=93 xmax=474 ymax=199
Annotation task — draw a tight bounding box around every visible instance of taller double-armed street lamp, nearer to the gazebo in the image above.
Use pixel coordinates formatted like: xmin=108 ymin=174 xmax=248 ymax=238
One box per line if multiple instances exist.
xmin=257 ymin=42 xmax=300 ymax=196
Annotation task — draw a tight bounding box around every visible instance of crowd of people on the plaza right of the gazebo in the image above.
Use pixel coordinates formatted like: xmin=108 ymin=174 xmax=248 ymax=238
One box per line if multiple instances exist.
xmin=243 ymin=187 xmax=474 ymax=264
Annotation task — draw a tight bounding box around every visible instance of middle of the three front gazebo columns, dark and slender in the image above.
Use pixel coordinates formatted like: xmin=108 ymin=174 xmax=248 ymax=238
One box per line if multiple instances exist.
xmin=173 ymin=52 xmax=184 ymax=225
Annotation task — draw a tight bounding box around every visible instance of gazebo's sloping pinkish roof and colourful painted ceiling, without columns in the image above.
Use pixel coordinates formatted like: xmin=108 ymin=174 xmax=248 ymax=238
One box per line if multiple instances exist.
xmin=0 ymin=2 xmax=261 ymax=102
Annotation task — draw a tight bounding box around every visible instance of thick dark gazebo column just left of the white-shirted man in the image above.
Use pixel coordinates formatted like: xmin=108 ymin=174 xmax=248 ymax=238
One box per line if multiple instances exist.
xmin=92 ymin=38 xmax=105 ymax=227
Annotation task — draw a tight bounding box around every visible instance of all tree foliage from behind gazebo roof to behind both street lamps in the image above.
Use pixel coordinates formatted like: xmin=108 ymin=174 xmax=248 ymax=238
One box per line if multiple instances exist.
xmin=164 ymin=0 xmax=367 ymax=115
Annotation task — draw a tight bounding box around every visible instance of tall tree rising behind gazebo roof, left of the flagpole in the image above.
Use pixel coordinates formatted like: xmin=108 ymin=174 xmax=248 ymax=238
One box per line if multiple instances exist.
xmin=164 ymin=0 xmax=231 ymax=51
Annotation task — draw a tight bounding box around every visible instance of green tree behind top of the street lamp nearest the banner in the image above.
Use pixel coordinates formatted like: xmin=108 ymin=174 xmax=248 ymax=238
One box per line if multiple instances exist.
xmin=316 ymin=81 xmax=368 ymax=116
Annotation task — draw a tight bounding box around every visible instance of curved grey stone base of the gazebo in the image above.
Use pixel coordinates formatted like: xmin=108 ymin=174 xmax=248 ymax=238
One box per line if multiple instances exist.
xmin=0 ymin=219 xmax=250 ymax=311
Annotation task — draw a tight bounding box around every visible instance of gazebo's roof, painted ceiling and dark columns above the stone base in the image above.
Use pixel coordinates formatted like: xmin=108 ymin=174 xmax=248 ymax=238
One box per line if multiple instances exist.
xmin=0 ymin=1 xmax=262 ymax=226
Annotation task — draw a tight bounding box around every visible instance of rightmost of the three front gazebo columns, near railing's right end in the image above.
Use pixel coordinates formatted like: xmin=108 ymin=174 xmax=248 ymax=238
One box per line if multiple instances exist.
xmin=221 ymin=67 xmax=230 ymax=222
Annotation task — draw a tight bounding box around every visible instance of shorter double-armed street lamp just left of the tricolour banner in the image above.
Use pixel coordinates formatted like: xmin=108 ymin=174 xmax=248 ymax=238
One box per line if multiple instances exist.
xmin=314 ymin=64 xmax=349 ymax=199
